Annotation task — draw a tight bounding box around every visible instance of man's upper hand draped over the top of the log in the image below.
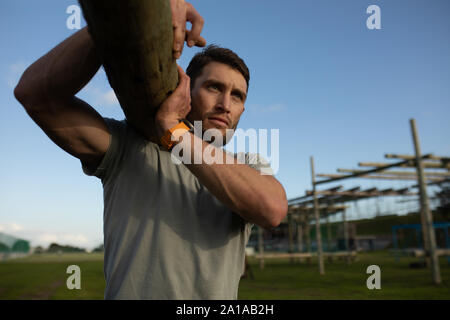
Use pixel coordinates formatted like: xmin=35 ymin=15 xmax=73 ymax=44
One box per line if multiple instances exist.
xmin=170 ymin=0 xmax=206 ymax=59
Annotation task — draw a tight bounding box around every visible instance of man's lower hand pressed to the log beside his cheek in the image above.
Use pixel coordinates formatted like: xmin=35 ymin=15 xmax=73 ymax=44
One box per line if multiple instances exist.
xmin=155 ymin=66 xmax=191 ymax=140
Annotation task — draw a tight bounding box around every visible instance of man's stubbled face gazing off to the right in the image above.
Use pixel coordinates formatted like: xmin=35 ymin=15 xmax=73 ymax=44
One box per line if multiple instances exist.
xmin=187 ymin=62 xmax=247 ymax=144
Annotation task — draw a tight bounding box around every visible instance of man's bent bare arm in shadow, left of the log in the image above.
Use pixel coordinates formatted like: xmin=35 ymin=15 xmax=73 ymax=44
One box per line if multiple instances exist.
xmin=14 ymin=28 xmax=110 ymax=167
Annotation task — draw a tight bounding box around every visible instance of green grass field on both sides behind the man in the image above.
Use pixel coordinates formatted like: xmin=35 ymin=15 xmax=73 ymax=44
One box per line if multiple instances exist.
xmin=0 ymin=252 xmax=450 ymax=300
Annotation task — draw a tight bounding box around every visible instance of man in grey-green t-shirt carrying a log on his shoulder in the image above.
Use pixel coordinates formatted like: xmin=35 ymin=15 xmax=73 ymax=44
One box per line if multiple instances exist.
xmin=15 ymin=1 xmax=287 ymax=299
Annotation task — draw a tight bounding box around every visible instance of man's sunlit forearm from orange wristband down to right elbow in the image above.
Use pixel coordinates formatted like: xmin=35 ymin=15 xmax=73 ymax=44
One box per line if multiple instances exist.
xmin=176 ymin=134 xmax=287 ymax=228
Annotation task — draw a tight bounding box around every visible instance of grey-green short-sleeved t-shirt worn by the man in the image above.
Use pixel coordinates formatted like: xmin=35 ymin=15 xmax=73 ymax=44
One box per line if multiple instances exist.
xmin=82 ymin=118 xmax=270 ymax=299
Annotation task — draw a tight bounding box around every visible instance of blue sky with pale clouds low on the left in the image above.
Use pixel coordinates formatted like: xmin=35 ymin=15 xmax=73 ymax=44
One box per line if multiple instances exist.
xmin=0 ymin=0 xmax=450 ymax=248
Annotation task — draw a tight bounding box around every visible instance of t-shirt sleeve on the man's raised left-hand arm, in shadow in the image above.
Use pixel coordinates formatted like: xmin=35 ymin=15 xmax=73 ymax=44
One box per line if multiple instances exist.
xmin=81 ymin=118 xmax=127 ymax=182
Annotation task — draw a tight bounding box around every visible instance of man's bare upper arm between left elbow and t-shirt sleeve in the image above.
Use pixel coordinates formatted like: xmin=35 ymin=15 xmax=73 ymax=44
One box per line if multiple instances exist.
xmin=25 ymin=97 xmax=111 ymax=167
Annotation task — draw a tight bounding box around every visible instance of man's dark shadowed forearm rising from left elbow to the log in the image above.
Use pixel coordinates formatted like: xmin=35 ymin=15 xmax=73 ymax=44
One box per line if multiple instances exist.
xmin=15 ymin=28 xmax=101 ymax=105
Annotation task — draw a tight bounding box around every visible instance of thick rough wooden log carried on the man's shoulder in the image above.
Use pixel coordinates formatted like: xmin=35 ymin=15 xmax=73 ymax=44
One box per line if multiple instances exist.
xmin=80 ymin=0 xmax=178 ymax=139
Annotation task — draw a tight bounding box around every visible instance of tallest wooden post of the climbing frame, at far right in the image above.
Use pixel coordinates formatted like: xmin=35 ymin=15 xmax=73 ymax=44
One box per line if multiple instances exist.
xmin=410 ymin=119 xmax=441 ymax=284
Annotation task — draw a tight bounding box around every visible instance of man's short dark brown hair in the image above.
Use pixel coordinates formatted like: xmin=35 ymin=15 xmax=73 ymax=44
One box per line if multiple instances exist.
xmin=186 ymin=44 xmax=250 ymax=92
